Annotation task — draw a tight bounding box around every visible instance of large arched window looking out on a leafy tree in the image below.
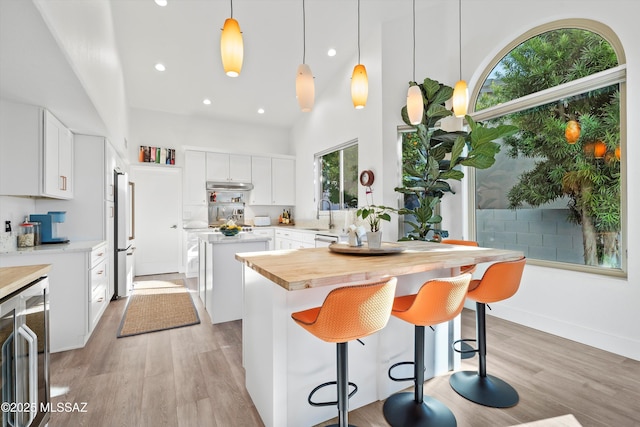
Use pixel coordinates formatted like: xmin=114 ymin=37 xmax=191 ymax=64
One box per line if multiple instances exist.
xmin=472 ymin=20 xmax=626 ymax=275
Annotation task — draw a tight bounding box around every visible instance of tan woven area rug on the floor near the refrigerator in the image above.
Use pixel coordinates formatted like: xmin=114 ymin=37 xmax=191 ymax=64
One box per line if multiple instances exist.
xmin=118 ymin=280 xmax=200 ymax=338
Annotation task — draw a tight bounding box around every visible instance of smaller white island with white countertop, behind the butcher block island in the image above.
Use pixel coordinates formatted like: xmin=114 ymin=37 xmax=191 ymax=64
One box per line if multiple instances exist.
xmin=198 ymin=232 xmax=270 ymax=323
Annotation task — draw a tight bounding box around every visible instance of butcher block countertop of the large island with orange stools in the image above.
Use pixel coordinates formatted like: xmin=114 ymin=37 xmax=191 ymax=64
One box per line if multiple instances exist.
xmin=236 ymin=241 xmax=523 ymax=291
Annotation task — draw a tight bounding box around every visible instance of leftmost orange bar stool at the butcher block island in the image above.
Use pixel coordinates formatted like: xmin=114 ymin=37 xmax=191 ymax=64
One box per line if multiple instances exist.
xmin=291 ymin=277 xmax=397 ymax=427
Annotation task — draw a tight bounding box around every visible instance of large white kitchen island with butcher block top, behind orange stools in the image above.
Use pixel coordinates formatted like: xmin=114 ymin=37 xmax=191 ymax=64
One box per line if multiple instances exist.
xmin=236 ymin=242 xmax=522 ymax=427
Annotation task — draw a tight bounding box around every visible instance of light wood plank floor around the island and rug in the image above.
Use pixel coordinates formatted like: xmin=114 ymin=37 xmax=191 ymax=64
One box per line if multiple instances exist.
xmin=49 ymin=275 xmax=640 ymax=427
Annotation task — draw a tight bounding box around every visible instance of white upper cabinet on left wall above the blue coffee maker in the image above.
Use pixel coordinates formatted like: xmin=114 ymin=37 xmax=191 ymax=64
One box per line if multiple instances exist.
xmin=0 ymin=101 xmax=74 ymax=199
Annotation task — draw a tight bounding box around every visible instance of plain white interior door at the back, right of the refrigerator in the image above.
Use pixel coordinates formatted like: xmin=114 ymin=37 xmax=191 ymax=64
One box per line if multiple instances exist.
xmin=131 ymin=166 xmax=182 ymax=276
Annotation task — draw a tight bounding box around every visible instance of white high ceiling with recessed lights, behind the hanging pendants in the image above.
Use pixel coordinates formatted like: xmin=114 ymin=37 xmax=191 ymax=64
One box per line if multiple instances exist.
xmin=111 ymin=0 xmax=411 ymax=127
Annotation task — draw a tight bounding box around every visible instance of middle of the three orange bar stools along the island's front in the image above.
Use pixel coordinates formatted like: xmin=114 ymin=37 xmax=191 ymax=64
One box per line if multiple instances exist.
xmin=382 ymin=274 xmax=471 ymax=427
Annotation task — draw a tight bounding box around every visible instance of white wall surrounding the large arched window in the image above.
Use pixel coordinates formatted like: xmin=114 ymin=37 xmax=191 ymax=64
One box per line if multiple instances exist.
xmin=292 ymin=0 xmax=640 ymax=360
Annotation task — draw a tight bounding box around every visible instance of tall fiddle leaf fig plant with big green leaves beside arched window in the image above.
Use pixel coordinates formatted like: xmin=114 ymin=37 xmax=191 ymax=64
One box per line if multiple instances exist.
xmin=395 ymin=78 xmax=518 ymax=240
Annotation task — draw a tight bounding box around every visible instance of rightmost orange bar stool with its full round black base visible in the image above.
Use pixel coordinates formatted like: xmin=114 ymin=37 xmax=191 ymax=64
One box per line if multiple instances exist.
xmin=449 ymin=258 xmax=526 ymax=408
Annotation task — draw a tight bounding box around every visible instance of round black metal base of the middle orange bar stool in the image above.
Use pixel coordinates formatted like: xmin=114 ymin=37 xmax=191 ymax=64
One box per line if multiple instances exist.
xmin=382 ymin=393 xmax=457 ymax=427
